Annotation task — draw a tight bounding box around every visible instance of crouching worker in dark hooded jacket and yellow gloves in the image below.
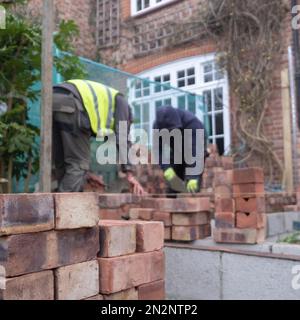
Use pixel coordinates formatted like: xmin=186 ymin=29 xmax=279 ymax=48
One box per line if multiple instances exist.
xmin=153 ymin=106 xmax=208 ymax=194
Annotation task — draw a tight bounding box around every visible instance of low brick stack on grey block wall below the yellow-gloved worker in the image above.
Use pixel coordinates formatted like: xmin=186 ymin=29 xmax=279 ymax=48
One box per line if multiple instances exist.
xmin=129 ymin=197 xmax=211 ymax=241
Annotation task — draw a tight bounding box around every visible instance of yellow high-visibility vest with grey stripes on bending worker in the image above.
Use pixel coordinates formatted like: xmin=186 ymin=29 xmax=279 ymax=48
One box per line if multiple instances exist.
xmin=67 ymin=80 xmax=119 ymax=135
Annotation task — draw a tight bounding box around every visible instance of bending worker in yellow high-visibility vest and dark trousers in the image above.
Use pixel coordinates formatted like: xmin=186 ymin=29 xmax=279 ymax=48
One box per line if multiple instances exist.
xmin=53 ymin=80 xmax=144 ymax=195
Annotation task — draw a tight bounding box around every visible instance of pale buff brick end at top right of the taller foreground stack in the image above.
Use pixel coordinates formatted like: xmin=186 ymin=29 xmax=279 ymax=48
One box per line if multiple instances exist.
xmin=54 ymin=193 xmax=99 ymax=230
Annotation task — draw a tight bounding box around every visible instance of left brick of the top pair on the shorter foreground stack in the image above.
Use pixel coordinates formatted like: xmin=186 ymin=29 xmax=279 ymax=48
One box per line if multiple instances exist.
xmin=99 ymin=220 xmax=136 ymax=258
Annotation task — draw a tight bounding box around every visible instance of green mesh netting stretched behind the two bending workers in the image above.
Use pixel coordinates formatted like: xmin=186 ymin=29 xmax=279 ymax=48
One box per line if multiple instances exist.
xmin=22 ymin=50 xmax=210 ymax=190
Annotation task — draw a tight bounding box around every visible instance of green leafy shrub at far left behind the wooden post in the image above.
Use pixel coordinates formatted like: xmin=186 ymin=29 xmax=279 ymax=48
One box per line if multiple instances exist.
xmin=0 ymin=6 xmax=85 ymax=192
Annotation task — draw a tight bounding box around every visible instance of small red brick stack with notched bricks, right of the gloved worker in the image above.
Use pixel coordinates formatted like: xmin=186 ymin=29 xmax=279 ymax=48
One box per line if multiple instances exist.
xmin=213 ymin=168 xmax=266 ymax=244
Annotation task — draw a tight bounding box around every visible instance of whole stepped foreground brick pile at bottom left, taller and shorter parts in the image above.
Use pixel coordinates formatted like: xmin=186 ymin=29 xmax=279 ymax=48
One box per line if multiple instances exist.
xmin=0 ymin=193 xmax=164 ymax=300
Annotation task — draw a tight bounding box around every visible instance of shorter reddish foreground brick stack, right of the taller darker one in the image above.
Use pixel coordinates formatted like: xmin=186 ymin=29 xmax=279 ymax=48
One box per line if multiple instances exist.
xmin=99 ymin=220 xmax=165 ymax=300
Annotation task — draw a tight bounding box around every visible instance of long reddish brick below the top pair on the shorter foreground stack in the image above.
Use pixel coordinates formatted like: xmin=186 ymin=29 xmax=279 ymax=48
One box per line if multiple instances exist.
xmin=98 ymin=251 xmax=165 ymax=294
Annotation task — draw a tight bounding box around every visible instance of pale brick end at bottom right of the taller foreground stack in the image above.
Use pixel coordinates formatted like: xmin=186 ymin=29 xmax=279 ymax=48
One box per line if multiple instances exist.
xmin=54 ymin=260 xmax=99 ymax=300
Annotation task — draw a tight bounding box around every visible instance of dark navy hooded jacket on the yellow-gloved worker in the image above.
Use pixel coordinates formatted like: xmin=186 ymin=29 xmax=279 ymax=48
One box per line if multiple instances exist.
xmin=153 ymin=106 xmax=207 ymax=179
